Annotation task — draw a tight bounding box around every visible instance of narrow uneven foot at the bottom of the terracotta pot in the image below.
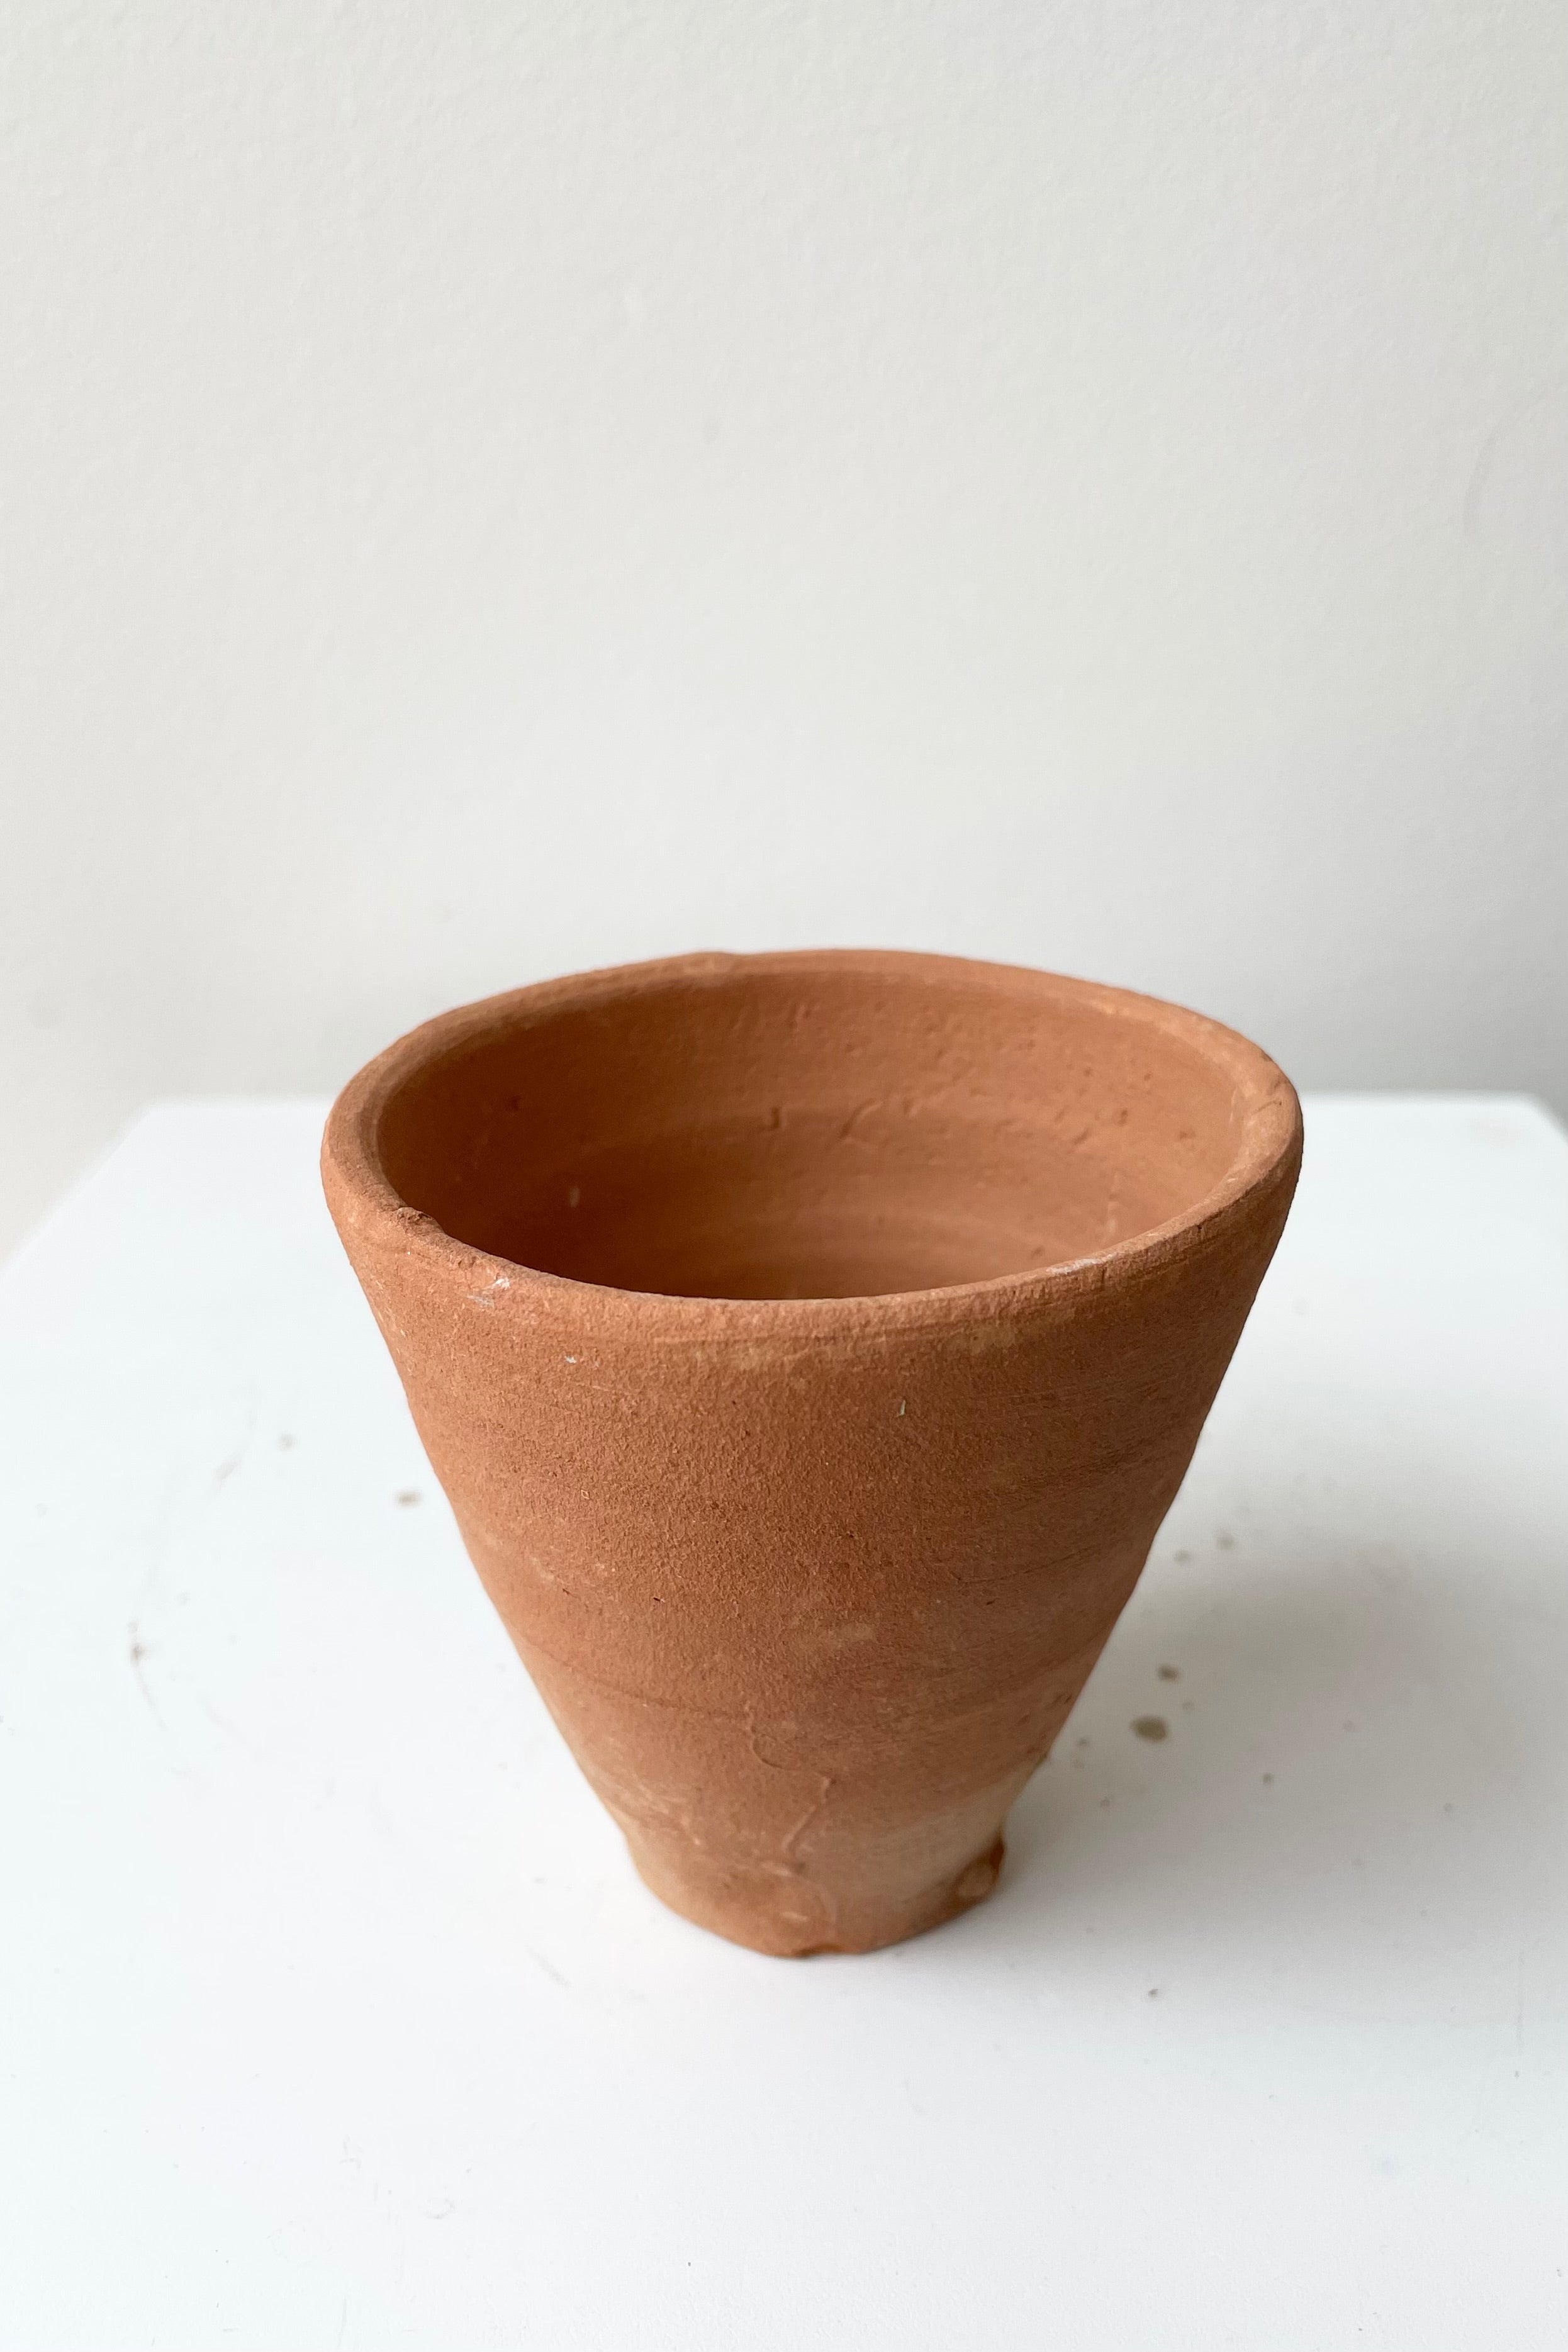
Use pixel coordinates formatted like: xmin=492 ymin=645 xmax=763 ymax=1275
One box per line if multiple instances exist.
xmin=628 ymin=1835 xmax=1006 ymax=1959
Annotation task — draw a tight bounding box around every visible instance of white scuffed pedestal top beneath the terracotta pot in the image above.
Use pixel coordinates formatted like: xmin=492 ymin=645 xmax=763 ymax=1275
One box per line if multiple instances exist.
xmin=0 ymin=1099 xmax=1568 ymax=2352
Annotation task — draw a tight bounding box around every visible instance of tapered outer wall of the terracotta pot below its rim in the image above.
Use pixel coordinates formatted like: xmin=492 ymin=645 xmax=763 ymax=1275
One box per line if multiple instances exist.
xmin=325 ymin=1148 xmax=1300 ymax=1952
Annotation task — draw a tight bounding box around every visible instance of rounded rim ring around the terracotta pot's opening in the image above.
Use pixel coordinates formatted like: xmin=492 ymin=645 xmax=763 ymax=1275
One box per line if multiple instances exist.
xmin=322 ymin=948 xmax=1302 ymax=1345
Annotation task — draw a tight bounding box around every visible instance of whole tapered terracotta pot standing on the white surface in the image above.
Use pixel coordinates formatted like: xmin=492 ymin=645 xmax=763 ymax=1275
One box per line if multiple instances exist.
xmin=322 ymin=953 xmax=1300 ymax=1952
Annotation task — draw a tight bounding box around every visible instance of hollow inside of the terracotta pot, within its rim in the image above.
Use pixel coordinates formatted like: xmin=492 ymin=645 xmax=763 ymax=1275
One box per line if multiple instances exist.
xmin=379 ymin=957 xmax=1246 ymax=1298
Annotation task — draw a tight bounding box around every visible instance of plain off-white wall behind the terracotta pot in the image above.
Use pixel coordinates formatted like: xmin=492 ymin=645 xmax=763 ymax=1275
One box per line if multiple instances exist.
xmin=0 ymin=0 xmax=1568 ymax=1233
